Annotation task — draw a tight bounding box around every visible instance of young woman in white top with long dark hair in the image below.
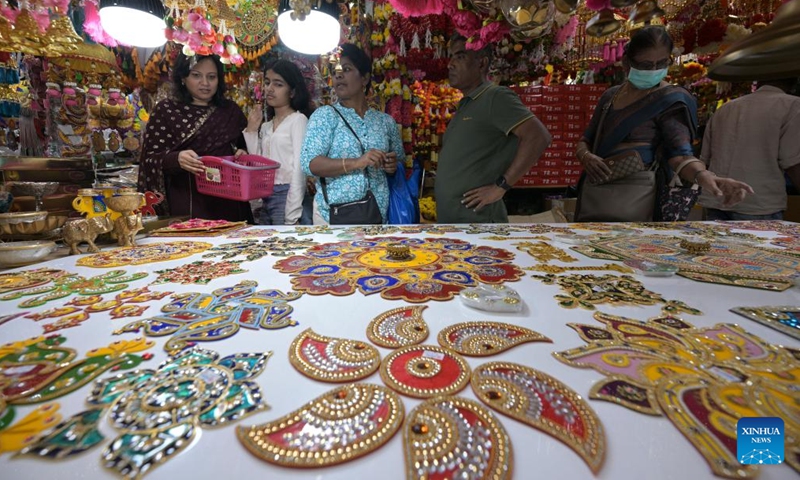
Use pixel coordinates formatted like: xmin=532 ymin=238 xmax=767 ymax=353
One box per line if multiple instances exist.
xmin=244 ymin=60 xmax=311 ymax=225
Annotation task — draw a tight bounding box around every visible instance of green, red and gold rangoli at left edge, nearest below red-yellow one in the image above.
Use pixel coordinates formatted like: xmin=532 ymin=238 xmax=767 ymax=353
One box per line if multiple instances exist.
xmin=0 ymin=270 xmax=147 ymax=308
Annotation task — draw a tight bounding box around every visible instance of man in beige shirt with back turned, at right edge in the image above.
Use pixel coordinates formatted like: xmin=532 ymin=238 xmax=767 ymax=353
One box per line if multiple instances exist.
xmin=700 ymin=78 xmax=800 ymax=220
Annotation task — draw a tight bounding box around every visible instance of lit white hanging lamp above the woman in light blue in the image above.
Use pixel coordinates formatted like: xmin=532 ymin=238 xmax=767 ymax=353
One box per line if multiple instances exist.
xmin=278 ymin=0 xmax=341 ymax=55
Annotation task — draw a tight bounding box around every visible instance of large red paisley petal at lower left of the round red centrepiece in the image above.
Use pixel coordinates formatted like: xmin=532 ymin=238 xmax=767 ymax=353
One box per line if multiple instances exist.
xmin=236 ymin=383 xmax=405 ymax=467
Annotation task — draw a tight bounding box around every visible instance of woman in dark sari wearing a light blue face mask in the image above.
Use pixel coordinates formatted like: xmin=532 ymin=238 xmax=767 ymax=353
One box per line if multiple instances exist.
xmin=575 ymin=26 xmax=753 ymax=221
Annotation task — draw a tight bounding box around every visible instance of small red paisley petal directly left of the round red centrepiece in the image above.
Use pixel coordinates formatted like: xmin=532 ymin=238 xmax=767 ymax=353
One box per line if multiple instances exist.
xmin=289 ymin=328 xmax=381 ymax=382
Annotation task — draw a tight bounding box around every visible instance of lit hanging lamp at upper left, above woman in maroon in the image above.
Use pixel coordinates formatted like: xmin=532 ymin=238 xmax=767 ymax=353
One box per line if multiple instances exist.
xmin=100 ymin=0 xmax=167 ymax=48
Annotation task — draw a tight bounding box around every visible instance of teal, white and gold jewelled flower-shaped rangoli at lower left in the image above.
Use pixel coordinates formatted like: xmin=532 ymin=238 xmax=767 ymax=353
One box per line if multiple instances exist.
xmin=81 ymin=347 xmax=272 ymax=478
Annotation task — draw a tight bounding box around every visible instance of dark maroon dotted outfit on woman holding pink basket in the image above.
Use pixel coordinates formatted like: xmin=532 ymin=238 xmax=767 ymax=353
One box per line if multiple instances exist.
xmin=139 ymin=100 xmax=253 ymax=223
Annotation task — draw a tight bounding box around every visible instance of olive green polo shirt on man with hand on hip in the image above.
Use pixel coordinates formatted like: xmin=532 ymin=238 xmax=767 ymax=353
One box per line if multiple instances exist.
xmin=436 ymin=82 xmax=533 ymax=223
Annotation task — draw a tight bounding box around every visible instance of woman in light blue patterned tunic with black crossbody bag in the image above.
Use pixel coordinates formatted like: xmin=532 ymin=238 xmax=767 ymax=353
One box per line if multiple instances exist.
xmin=300 ymin=43 xmax=404 ymax=225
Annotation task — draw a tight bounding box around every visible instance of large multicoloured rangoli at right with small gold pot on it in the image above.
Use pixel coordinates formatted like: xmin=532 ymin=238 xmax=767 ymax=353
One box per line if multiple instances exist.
xmin=572 ymin=235 xmax=800 ymax=291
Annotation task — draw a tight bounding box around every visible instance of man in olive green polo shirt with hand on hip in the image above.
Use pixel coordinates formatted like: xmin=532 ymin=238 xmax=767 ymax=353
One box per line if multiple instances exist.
xmin=436 ymin=35 xmax=551 ymax=223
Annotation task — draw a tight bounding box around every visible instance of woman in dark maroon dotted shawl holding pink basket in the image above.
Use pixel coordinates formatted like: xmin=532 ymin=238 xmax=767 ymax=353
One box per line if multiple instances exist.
xmin=139 ymin=53 xmax=253 ymax=223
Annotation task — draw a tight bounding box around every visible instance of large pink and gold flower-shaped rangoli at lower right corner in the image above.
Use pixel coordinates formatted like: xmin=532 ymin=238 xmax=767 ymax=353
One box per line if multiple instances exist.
xmin=554 ymin=312 xmax=800 ymax=478
